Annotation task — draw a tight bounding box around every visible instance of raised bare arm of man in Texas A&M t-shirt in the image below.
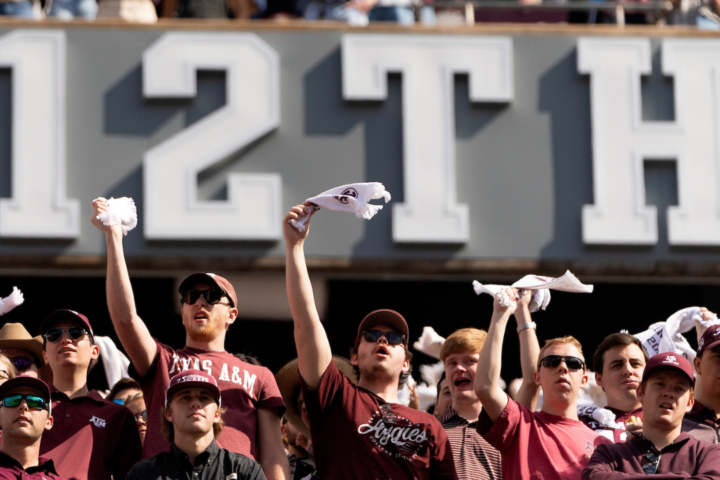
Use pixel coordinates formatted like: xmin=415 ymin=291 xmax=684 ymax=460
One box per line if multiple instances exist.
xmin=91 ymin=199 xmax=157 ymax=377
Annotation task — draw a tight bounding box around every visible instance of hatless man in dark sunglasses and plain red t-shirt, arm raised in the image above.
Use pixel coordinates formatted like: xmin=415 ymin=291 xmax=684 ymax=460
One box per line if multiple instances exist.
xmin=475 ymin=288 xmax=610 ymax=480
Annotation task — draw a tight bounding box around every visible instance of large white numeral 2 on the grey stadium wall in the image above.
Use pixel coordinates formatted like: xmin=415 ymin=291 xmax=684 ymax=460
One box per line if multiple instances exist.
xmin=143 ymin=33 xmax=282 ymax=240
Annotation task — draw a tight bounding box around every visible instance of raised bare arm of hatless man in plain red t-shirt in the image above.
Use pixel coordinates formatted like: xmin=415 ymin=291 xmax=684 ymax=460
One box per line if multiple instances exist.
xmin=475 ymin=288 xmax=517 ymax=422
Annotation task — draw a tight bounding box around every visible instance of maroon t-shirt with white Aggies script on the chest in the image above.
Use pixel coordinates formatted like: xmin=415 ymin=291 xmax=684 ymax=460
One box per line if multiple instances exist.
xmin=303 ymin=362 xmax=457 ymax=480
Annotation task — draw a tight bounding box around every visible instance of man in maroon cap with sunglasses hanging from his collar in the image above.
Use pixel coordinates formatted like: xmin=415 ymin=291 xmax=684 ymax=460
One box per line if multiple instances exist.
xmin=582 ymin=352 xmax=720 ymax=480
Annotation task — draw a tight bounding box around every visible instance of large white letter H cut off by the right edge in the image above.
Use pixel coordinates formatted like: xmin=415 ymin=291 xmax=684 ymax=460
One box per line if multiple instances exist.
xmin=578 ymin=38 xmax=720 ymax=245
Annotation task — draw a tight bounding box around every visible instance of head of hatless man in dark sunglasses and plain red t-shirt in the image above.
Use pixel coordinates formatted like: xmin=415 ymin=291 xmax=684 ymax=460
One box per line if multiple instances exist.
xmin=533 ymin=343 xmax=588 ymax=405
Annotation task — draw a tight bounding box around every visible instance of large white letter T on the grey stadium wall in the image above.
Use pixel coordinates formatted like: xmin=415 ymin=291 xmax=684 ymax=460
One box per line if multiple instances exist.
xmin=342 ymin=34 xmax=513 ymax=243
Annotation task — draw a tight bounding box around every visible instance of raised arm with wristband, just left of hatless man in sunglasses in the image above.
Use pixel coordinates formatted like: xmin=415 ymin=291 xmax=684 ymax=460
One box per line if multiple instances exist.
xmin=515 ymin=290 xmax=540 ymax=410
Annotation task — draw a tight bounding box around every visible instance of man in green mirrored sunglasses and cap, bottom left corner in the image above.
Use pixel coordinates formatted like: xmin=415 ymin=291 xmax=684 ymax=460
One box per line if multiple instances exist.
xmin=0 ymin=375 xmax=66 ymax=480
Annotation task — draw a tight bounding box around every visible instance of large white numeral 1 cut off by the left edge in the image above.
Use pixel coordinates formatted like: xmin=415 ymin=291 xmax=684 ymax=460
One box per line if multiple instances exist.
xmin=0 ymin=30 xmax=80 ymax=239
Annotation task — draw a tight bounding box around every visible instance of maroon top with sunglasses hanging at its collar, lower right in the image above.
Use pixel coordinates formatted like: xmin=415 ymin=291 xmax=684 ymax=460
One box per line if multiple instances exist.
xmin=582 ymin=432 xmax=720 ymax=480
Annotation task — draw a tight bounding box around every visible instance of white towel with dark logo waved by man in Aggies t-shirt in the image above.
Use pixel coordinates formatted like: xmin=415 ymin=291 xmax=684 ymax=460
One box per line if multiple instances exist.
xmin=290 ymin=182 xmax=391 ymax=232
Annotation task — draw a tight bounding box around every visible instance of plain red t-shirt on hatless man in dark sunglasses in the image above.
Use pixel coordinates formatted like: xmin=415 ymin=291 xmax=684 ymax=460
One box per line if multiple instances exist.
xmin=478 ymin=398 xmax=612 ymax=480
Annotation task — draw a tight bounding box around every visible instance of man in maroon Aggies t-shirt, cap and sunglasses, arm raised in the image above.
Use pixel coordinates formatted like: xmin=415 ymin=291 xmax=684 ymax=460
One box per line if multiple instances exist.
xmin=283 ymin=205 xmax=457 ymax=480
